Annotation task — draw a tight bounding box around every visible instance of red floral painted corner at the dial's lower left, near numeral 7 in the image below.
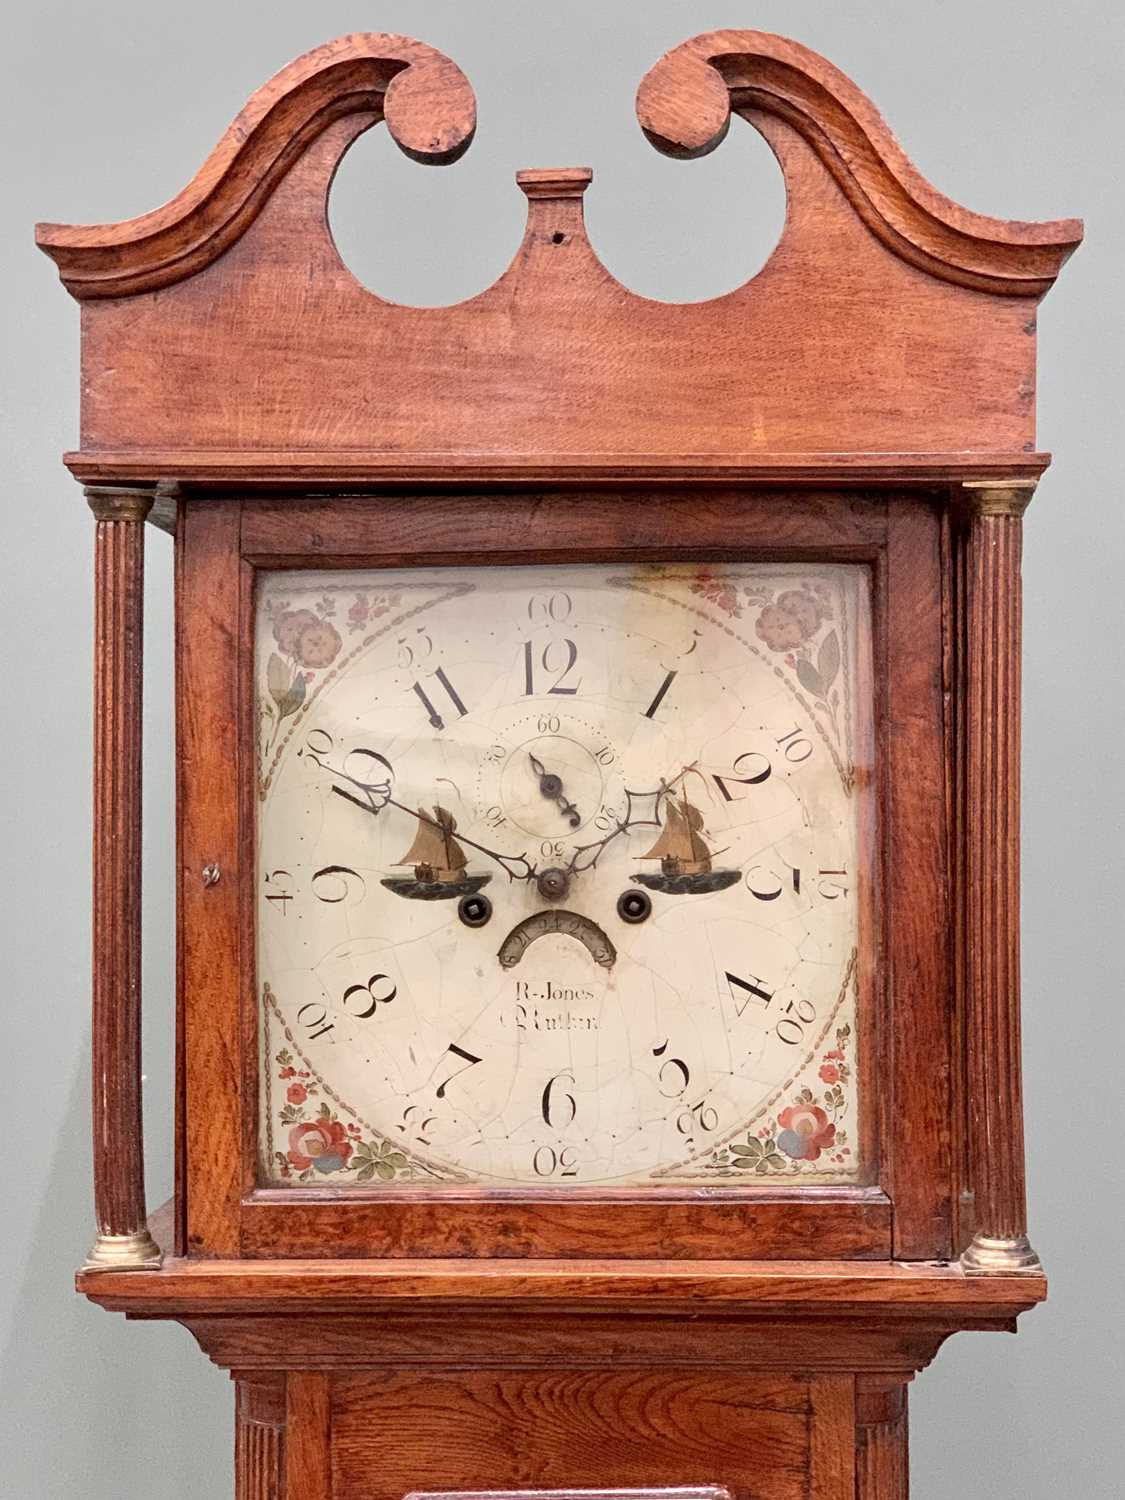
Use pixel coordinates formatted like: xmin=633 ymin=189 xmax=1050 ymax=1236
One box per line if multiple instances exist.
xmin=273 ymin=1047 xmax=435 ymax=1182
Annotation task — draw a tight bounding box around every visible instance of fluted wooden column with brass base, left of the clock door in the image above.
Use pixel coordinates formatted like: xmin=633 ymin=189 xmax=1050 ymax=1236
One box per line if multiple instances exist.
xmin=84 ymin=486 xmax=161 ymax=1271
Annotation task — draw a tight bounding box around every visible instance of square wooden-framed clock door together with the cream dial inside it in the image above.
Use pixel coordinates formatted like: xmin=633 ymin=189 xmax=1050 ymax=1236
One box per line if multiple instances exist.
xmin=183 ymin=495 xmax=950 ymax=1259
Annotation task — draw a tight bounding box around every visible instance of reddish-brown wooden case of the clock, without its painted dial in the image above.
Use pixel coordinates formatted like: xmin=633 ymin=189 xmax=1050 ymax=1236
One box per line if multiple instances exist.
xmin=38 ymin=32 xmax=1082 ymax=1500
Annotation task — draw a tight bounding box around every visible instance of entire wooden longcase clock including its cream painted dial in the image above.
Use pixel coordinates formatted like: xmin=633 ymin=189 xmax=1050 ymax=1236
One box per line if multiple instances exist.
xmin=39 ymin=32 xmax=1082 ymax=1500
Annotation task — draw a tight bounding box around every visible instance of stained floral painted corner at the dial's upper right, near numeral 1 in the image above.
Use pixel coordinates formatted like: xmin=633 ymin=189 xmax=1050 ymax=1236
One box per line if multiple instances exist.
xmin=692 ymin=572 xmax=843 ymax=741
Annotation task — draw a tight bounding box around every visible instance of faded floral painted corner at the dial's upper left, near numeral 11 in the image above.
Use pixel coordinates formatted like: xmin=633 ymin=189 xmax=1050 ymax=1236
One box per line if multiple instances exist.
xmin=260 ymin=591 xmax=398 ymax=756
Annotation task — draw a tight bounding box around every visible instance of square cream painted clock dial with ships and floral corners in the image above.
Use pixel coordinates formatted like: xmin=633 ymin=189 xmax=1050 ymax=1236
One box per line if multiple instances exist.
xmin=257 ymin=564 xmax=870 ymax=1190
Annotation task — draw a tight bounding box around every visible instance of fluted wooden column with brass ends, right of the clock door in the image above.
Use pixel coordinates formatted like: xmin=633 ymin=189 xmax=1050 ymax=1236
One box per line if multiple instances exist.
xmin=962 ymin=483 xmax=1040 ymax=1274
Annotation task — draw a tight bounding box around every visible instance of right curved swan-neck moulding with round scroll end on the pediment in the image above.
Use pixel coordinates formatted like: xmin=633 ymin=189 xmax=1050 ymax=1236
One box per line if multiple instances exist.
xmin=636 ymin=32 xmax=1083 ymax=297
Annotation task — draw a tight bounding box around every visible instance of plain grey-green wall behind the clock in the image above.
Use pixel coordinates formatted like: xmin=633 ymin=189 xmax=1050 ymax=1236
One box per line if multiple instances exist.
xmin=0 ymin=0 xmax=1125 ymax=1500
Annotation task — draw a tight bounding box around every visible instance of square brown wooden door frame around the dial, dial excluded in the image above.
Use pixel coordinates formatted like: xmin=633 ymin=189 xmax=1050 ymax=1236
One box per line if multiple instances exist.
xmin=179 ymin=492 xmax=954 ymax=1260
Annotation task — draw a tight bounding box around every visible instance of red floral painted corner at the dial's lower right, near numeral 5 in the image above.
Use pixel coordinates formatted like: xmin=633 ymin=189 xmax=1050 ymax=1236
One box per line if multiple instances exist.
xmin=707 ymin=1025 xmax=855 ymax=1178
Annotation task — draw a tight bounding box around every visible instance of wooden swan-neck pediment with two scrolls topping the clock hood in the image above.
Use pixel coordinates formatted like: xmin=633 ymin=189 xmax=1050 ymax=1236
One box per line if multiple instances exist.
xmin=39 ymin=32 xmax=1080 ymax=486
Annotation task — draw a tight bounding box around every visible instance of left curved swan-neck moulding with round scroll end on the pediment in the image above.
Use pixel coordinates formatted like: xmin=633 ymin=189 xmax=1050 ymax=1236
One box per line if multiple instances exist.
xmin=36 ymin=33 xmax=477 ymax=300
